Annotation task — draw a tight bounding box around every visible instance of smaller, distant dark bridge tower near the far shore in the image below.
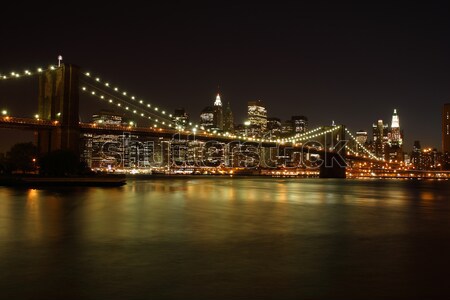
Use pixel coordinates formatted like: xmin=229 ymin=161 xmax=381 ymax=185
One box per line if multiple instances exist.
xmin=319 ymin=125 xmax=347 ymax=178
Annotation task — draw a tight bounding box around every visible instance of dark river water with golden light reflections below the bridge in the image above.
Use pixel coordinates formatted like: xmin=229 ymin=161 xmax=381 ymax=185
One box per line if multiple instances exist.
xmin=0 ymin=177 xmax=450 ymax=300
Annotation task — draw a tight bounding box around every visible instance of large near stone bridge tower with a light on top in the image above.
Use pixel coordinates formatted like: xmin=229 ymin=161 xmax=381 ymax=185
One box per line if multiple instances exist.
xmin=37 ymin=64 xmax=80 ymax=156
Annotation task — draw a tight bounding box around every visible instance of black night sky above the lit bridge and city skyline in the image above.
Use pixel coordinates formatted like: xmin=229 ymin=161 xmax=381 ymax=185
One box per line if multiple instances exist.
xmin=0 ymin=1 xmax=450 ymax=151
